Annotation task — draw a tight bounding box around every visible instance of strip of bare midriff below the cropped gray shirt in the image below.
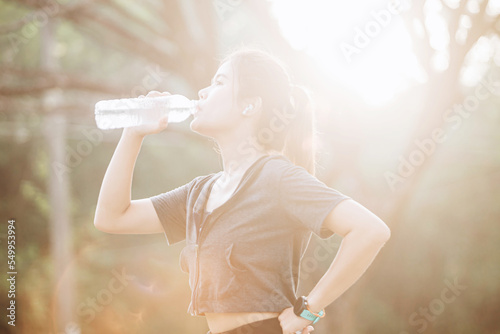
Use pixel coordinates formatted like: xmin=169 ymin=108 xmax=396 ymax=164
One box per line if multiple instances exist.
xmin=205 ymin=312 xmax=279 ymax=333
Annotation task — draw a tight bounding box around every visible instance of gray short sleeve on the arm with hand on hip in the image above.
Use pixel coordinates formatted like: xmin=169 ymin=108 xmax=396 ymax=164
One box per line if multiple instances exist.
xmin=279 ymin=165 xmax=350 ymax=239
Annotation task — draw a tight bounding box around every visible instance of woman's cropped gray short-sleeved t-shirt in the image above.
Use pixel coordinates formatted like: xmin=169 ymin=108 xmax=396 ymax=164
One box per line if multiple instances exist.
xmin=151 ymin=155 xmax=350 ymax=315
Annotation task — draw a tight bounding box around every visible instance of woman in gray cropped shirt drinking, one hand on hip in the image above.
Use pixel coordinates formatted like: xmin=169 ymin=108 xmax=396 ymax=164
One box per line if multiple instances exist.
xmin=94 ymin=50 xmax=390 ymax=334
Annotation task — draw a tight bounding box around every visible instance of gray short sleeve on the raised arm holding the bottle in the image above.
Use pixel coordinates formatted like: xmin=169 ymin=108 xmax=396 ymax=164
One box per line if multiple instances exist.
xmin=150 ymin=180 xmax=194 ymax=245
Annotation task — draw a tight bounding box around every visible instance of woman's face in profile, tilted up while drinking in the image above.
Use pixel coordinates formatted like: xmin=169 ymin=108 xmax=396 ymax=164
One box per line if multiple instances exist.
xmin=190 ymin=61 xmax=243 ymax=138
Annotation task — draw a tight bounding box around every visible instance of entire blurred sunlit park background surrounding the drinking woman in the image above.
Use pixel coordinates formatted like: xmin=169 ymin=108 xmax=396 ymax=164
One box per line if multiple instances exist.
xmin=0 ymin=0 xmax=500 ymax=334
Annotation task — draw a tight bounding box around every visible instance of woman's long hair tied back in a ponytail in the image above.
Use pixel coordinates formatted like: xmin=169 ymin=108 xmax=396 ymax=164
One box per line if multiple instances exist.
xmin=222 ymin=49 xmax=315 ymax=175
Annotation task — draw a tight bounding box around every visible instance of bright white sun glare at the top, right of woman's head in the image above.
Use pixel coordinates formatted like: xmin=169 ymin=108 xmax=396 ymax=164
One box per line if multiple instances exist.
xmin=273 ymin=0 xmax=425 ymax=105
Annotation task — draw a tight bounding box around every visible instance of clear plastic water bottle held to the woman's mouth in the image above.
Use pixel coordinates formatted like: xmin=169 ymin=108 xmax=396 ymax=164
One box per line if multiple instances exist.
xmin=95 ymin=95 xmax=198 ymax=130
